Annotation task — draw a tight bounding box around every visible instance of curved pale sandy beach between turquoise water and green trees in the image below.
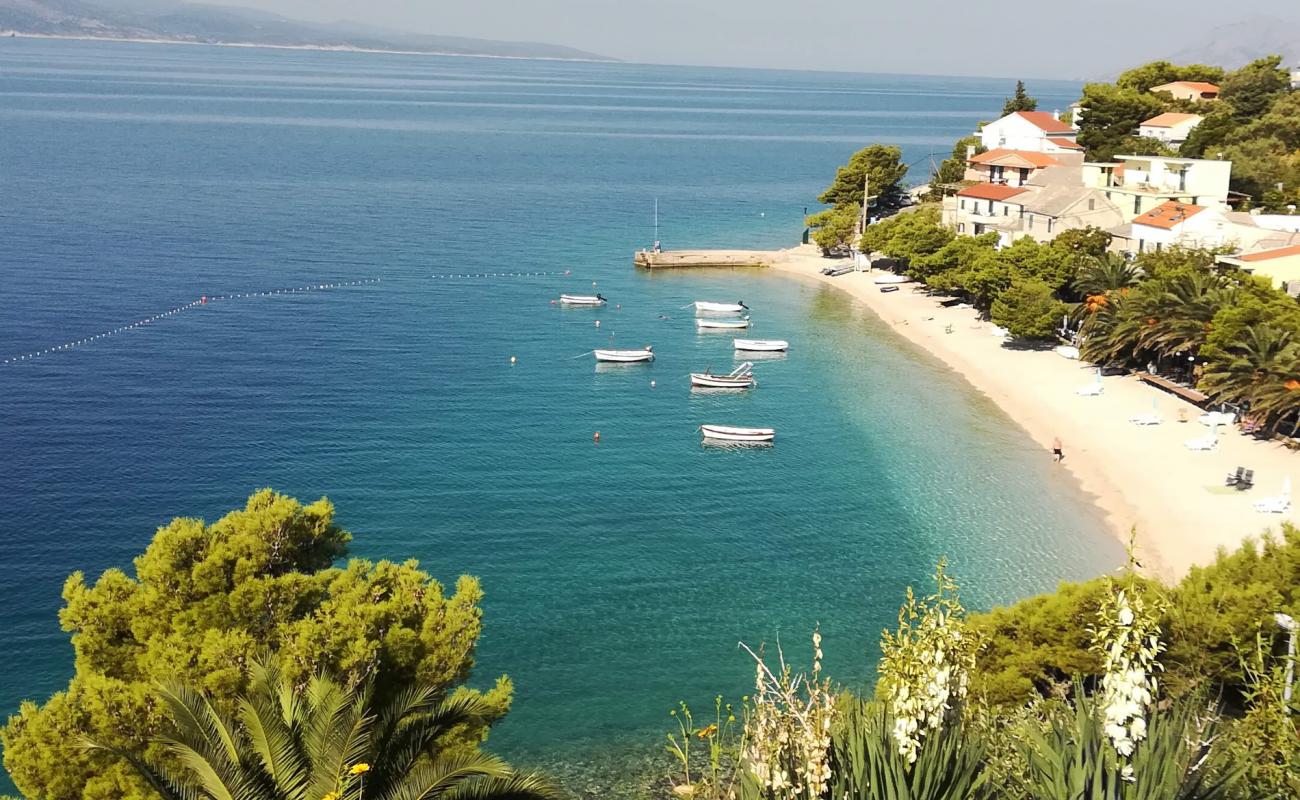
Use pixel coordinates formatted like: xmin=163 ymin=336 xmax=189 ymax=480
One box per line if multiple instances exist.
xmin=772 ymin=246 xmax=1300 ymax=579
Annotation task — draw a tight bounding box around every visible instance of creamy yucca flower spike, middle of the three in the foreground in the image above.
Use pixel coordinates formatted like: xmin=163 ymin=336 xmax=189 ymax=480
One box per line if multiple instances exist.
xmin=880 ymin=563 xmax=975 ymax=764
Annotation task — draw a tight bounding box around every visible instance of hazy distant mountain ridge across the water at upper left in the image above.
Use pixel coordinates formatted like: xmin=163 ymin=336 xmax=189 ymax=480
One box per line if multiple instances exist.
xmin=0 ymin=0 xmax=615 ymax=61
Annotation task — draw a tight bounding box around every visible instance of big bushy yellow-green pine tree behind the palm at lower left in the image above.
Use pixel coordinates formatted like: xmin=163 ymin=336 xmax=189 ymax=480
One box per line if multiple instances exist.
xmin=3 ymin=489 xmax=511 ymax=800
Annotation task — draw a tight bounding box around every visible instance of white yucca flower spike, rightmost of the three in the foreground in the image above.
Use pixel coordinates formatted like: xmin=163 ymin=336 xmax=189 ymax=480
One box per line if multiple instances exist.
xmin=1095 ymin=589 xmax=1162 ymax=779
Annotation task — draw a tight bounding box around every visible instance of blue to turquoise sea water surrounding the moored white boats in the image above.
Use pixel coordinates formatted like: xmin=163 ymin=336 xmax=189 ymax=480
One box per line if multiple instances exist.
xmin=0 ymin=39 xmax=1123 ymax=796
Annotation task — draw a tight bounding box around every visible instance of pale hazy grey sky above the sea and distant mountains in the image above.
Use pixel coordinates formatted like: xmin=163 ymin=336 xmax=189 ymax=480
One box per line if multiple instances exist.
xmin=202 ymin=0 xmax=1300 ymax=78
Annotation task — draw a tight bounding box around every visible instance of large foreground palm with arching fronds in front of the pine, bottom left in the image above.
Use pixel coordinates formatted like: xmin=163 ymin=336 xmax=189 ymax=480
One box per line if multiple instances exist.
xmin=91 ymin=663 xmax=558 ymax=800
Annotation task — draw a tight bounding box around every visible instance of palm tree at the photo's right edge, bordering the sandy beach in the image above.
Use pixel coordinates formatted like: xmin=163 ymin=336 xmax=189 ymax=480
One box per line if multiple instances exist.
xmin=1201 ymin=324 xmax=1300 ymax=429
